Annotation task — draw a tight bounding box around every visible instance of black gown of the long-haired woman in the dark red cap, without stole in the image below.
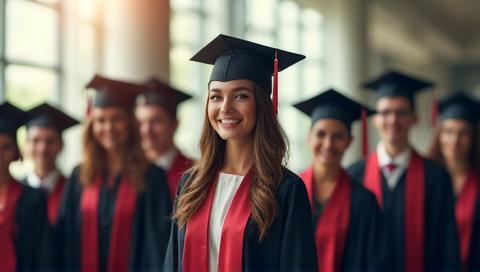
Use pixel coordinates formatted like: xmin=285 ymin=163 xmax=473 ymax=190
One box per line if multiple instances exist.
xmin=56 ymin=165 xmax=172 ymax=271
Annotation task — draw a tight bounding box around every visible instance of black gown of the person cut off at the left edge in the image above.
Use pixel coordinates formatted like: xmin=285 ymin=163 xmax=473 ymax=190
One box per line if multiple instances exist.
xmin=12 ymin=185 xmax=56 ymax=271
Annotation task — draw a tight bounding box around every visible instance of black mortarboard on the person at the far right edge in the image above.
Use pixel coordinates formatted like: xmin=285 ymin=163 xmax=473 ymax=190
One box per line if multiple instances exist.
xmin=439 ymin=91 xmax=480 ymax=124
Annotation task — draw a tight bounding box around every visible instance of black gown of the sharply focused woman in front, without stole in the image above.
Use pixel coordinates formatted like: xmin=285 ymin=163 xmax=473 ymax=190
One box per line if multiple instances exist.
xmin=165 ymin=169 xmax=317 ymax=271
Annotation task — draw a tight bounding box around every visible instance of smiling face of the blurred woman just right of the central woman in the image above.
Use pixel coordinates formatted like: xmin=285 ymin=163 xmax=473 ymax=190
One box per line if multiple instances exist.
xmin=307 ymin=118 xmax=351 ymax=166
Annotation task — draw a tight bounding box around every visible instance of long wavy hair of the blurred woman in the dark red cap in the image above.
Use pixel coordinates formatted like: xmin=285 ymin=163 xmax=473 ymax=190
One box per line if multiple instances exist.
xmin=80 ymin=109 xmax=149 ymax=190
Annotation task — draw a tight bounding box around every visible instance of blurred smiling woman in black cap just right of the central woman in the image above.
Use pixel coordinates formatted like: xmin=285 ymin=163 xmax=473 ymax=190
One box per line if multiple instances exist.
xmin=294 ymin=89 xmax=385 ymax=272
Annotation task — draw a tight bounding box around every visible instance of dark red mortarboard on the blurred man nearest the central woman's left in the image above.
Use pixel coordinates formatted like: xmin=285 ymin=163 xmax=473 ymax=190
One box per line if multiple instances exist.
xmin=136 ymin=77 xmax=192 ymax=117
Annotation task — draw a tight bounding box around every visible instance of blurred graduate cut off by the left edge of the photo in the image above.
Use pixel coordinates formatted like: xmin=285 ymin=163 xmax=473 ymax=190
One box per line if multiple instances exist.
xmin=0 ymin=102 xmax=55 ymax=271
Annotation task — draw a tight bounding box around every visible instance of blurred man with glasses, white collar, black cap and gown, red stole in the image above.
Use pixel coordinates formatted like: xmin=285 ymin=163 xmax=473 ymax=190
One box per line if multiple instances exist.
xmin=348 ymin=71 xmax=460 ymax=271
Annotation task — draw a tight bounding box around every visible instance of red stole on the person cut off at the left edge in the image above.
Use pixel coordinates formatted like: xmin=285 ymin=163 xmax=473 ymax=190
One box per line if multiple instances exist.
xmin=0 ymin=180 xmax=23 ymax=271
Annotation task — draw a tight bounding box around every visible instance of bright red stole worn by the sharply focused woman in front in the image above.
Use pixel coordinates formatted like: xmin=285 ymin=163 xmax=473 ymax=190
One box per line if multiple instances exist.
xmin=182 ymin=170 xmax=253 ymax=272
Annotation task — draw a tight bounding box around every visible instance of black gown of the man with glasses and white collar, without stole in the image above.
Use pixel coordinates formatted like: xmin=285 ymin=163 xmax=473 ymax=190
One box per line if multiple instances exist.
xmin=347 ymin=159 xmax=460 ymax=271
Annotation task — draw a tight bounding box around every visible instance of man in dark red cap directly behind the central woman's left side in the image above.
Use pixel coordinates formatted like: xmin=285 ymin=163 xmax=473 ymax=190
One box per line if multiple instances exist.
xmin=135 ymin=78 xmax=192 ymax=200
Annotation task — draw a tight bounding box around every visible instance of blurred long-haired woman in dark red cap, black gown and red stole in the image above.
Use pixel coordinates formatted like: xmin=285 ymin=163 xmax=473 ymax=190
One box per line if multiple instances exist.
xmin=57 ymin=75 xmax=171 ymax=271
